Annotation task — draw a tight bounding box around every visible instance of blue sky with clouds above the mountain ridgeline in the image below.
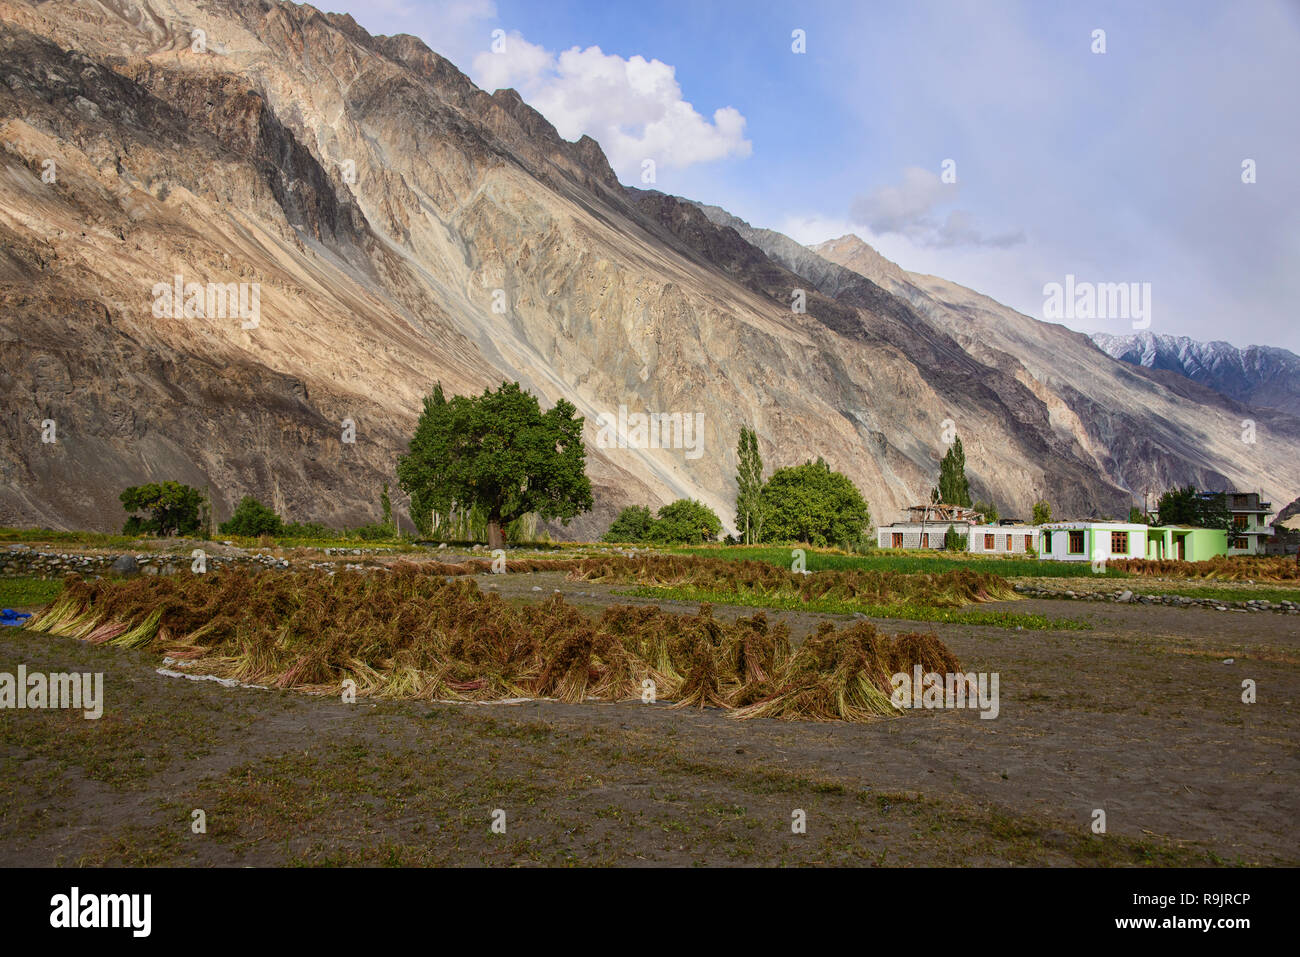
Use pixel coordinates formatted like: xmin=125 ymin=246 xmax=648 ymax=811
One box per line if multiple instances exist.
xmin=312 ymin=0 xmax=1300 ymax=351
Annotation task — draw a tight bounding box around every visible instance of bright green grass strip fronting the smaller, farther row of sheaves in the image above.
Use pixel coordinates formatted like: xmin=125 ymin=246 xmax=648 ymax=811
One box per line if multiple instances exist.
xmin=615 ymin=585 xmax=1092 ymax=631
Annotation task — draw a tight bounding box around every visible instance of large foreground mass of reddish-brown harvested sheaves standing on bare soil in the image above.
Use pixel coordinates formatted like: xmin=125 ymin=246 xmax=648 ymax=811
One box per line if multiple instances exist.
xmin=17 ymin=564 xmax=961 ymax=720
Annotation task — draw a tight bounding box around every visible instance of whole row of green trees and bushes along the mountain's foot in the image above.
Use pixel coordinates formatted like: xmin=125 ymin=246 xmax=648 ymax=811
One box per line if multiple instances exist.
xmin=121 ymin=382 xmax=1231 ymax=547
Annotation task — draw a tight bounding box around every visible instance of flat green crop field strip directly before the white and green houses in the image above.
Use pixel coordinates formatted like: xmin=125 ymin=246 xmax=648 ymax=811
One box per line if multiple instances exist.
xmin=668 ymin=545 xmax=1128 ymax=579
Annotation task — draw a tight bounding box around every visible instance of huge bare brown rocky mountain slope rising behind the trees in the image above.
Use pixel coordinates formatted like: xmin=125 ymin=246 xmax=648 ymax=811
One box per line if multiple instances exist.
xmin=0 ymin=0 xmax=1300 ymax=536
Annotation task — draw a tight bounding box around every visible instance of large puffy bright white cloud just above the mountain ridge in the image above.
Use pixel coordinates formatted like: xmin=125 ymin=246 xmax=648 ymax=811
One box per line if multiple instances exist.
xmin=471 ymin=33 xmax=753 ymax=185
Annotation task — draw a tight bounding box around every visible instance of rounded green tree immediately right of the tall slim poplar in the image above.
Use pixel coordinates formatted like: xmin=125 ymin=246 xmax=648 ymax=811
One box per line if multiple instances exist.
xmin=762 ymin=459 xmax=871 ymax=545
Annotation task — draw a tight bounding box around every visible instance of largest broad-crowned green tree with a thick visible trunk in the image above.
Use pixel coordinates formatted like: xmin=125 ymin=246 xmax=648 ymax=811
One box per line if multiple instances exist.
xmin=398 ymin=382 xmax=592 ymax=547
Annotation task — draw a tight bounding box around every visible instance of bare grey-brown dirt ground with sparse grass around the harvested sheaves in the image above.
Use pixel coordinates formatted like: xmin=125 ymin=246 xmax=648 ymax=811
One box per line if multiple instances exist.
xmin=0 ymin=573 xmax=1300 ymax=866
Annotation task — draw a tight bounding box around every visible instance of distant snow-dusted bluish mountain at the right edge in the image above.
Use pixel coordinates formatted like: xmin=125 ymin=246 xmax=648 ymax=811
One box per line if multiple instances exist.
xmin=1092 ymin=332 xmax=1300 ymax=415
